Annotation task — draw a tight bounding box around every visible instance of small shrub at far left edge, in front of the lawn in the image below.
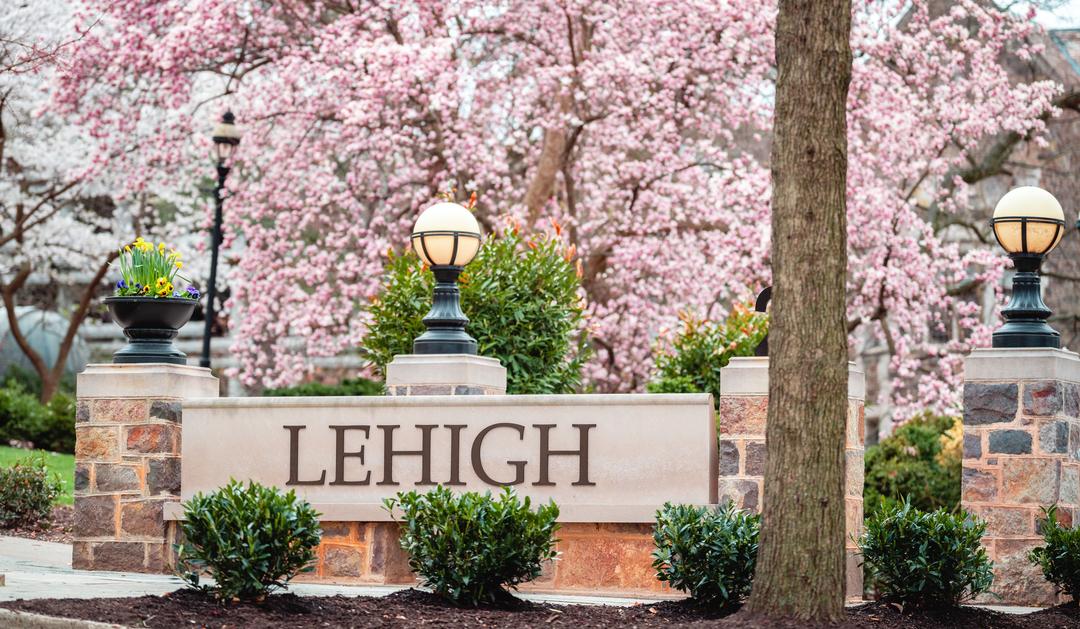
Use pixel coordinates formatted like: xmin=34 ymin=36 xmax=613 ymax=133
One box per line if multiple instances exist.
xmin=0 ymin=454 xmax=60 ymax=528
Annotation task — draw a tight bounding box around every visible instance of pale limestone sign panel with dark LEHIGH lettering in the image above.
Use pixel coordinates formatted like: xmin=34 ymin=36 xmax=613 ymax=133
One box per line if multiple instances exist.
xmin=166 ymin=394 xmax=717 ymax=522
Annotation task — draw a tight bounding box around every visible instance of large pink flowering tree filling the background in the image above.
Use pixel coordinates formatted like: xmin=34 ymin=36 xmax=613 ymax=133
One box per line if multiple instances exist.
xmin=57 ymin=0 xmax=1064 ymax=419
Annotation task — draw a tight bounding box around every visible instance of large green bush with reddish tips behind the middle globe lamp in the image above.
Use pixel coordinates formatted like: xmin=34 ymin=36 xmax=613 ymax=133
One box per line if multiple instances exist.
xmin=364 ymin=231 xmax=588 ymax=393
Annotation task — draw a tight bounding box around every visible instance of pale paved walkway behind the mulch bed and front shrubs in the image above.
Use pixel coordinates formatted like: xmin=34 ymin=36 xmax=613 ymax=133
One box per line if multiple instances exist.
xmin=0 ymin=536 xmax=1038 ymax=614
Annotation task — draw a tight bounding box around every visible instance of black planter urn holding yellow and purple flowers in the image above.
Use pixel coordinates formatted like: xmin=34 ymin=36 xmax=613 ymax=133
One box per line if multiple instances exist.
xmin=105 ymin=297 xmax=198 ymax=364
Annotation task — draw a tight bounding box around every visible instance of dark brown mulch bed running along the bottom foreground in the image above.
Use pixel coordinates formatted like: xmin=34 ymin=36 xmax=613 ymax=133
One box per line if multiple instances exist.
xmin=0 ymin=590 xmax=1080 ymax=629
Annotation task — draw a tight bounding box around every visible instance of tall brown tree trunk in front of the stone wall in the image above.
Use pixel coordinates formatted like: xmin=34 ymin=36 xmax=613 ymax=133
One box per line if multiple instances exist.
xmin=746 ymin=0 xmax=851 ymax=621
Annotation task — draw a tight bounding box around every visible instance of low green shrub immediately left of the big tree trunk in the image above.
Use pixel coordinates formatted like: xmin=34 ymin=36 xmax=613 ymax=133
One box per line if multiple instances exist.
xmin=652 ymin=503 xmax=761 ymax=608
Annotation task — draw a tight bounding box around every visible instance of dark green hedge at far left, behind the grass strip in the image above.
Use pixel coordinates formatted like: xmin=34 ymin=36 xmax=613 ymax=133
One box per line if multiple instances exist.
xmin=0 ymin=380 xmax=76 ymax=453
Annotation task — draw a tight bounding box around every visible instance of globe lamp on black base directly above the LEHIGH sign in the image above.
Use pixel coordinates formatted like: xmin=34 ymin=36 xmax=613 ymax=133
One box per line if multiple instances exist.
xmin=413 ymin=203 xmax=481 ymax=354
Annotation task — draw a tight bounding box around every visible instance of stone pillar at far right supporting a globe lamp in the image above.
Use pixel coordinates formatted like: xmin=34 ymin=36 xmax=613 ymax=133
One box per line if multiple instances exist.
xmin=961 ymin=348 xmax=1080 ymax=605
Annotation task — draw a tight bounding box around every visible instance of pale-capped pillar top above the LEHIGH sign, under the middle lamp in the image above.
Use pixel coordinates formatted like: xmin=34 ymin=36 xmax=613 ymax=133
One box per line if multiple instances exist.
xmin=387 ymin=353 xmax=507 ymax=396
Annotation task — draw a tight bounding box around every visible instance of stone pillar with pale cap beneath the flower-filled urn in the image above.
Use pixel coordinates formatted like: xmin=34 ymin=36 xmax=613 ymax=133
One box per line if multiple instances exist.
xmin=71 ymin=363 xmax=218 ymax=573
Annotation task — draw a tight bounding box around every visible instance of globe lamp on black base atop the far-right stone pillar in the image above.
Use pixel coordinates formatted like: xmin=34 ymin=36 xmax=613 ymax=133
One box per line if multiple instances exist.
xmin=990 ymin=186 xmax=1065 ymax=348
